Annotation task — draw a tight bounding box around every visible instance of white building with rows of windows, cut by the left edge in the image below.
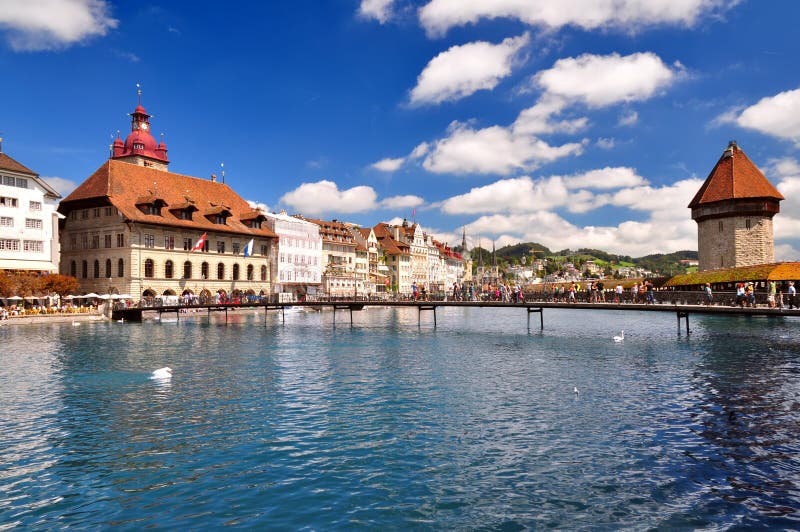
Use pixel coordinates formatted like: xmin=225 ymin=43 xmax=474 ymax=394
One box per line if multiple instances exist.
xmin=0 ymin=139 xmax=61 ymax=273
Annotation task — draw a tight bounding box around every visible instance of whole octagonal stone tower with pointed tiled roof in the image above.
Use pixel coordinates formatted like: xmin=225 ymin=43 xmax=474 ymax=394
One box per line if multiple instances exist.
xmin=689 ymin=142 xmax=784 ymax=270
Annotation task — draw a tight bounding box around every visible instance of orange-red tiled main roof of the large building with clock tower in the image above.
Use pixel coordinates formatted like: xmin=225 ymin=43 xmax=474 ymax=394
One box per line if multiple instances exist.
xmin=58 ymin=159 xmax=277 ymax=238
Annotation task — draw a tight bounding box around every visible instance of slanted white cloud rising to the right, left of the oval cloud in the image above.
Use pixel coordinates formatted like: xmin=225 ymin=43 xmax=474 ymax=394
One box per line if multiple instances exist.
xmin=410 ymin=34 xmax=530 ymax=105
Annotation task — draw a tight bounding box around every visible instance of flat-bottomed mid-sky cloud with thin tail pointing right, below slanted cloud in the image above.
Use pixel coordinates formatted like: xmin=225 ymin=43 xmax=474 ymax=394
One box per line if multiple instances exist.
xmin=423 ymin=122 xmax=583 ymax=175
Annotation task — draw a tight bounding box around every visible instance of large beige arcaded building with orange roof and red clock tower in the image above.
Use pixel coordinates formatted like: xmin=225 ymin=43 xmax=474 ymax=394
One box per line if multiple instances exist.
xmin=58 ymin=97 xmax=277 ymax=298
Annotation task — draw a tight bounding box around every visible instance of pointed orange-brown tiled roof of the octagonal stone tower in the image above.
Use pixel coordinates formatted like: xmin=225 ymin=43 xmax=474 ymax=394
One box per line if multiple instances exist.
xmin=689 ymin=142 xmax=784 ymax=208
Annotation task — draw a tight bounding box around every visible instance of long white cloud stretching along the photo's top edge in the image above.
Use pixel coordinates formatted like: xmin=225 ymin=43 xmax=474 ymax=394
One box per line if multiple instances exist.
xmin=419 ymin=0 xmax=738 ymax=36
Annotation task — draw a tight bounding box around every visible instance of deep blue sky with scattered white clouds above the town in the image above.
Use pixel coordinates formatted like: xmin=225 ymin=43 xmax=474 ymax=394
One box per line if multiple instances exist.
xmin=0 ymin=0 xmax=800 ymax=260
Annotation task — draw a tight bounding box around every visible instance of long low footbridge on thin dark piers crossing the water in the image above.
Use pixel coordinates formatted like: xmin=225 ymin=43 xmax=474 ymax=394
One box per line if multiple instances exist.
xmin=112 ymin=300 xmax=800 ymax=334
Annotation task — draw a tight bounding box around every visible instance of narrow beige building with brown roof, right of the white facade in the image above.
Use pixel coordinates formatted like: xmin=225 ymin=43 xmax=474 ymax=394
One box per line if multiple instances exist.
xmin=297 ymin=215 xmax=365 ymax=297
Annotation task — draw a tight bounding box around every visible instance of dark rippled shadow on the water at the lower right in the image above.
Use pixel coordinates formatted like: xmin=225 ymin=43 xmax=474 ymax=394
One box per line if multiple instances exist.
xmin=665 ymin=317 xmax=800 ymax=528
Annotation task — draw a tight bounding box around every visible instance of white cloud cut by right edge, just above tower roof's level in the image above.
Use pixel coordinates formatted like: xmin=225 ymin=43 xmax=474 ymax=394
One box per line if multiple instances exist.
xmin=732 ymin=89 xmax=800 ymax=145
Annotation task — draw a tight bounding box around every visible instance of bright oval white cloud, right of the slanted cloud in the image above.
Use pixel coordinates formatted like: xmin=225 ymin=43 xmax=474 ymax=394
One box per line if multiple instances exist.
xmin=535 ymin=52 xmax=677 ymax=107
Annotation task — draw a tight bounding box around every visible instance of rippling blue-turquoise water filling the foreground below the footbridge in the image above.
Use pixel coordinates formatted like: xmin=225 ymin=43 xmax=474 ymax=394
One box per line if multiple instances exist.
xmin=0 ymin=308 xmax=800 ymax=530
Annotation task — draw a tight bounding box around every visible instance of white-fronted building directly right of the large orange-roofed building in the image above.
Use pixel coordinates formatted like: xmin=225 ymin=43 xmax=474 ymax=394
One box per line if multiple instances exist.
xmin=264 ymin=211 xmax=323 ymax=299
